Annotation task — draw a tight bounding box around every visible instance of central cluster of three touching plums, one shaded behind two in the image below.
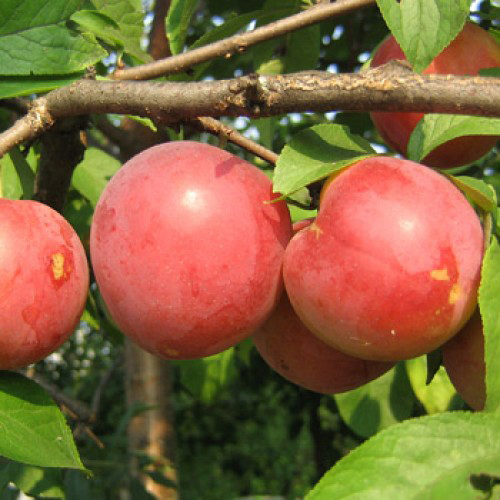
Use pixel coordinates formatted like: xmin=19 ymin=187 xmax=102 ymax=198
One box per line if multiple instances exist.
xmin=90 ymin=141 xmax=483 ymax=410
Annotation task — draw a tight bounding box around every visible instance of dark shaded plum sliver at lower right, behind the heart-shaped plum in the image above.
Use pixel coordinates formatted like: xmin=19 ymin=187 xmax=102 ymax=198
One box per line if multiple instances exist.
xmin=442 ymin=309 xmax=486 ymax=411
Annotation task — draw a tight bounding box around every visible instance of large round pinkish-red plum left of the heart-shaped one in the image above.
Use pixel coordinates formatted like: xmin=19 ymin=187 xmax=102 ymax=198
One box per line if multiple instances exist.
xmin=90 ymin=141 xmax=291 ymax=359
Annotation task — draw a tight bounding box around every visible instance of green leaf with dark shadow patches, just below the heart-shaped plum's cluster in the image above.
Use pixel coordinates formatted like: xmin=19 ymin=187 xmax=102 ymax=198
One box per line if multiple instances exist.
xmin=334 ymin=363 xmax=415 ymax=437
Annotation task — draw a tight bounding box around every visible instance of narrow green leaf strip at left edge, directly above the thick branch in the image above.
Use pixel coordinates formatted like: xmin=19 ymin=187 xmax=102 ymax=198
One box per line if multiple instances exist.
xmin=0 ymin=71 xmax=84 ymax=99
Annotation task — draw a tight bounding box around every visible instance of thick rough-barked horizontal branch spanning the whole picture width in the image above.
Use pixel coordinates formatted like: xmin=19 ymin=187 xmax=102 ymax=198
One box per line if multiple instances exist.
xmin=0 ymin=65 xmax=500 ymax=156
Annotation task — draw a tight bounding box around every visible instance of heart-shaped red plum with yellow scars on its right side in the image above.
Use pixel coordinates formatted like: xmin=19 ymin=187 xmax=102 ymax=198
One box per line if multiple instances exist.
xmin=283 ymin=157 xmax=483 ymax=361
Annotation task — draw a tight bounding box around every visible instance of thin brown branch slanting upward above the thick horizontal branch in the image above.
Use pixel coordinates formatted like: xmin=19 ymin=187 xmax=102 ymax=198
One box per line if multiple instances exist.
xmin=113 ymin=0 xmax=375 ymax=80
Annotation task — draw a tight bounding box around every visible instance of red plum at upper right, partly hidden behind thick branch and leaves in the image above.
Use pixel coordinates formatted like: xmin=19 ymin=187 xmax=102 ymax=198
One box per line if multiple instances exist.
xmin=370 ymin=22 xmax=500 ymax=168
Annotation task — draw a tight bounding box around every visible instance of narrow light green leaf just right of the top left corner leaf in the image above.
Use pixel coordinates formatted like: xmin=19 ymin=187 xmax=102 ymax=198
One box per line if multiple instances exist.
xmin=71 ymin=10 xmax=151 ymax=62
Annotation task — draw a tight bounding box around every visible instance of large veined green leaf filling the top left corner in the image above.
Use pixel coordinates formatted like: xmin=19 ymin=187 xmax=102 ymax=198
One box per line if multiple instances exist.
xmin=0 ymin=0 xmax=107 ymax=76
